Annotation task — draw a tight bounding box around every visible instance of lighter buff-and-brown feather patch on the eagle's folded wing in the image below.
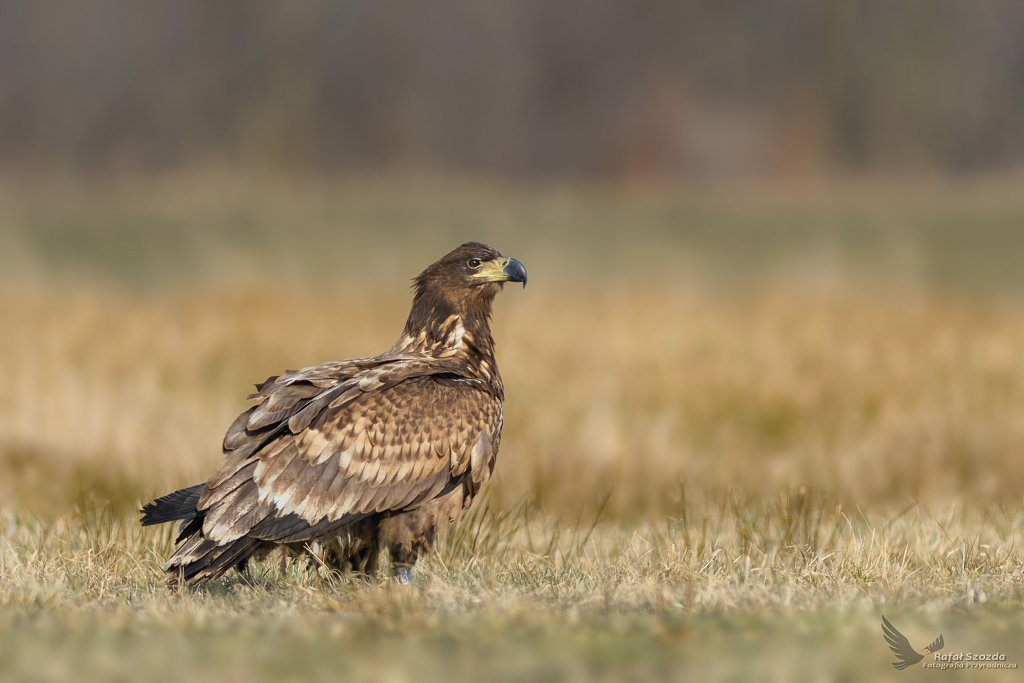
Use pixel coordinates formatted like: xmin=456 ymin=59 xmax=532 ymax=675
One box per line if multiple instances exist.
xmin=254 ymin=377 xmax=500 ymax=524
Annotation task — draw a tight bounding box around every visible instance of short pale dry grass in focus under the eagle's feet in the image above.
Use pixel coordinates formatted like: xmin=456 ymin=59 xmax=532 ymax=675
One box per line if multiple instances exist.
xmin=0 ymin=494 xmax=1024 ymax=681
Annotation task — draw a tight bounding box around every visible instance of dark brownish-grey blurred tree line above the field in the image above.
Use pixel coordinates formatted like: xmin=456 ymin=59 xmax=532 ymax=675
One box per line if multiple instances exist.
xmin=0 ymin=0 xmax=1024 ymax=176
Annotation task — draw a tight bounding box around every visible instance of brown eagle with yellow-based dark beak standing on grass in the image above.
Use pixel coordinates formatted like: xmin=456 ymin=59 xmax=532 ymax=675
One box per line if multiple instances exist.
xmin=140 ymin=242 xmax=526 ymax=588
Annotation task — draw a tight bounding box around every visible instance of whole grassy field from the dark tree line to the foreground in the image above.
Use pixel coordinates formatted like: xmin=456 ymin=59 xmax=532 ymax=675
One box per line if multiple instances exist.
xmin=0 ymin=176 xmax=1024 ymax=681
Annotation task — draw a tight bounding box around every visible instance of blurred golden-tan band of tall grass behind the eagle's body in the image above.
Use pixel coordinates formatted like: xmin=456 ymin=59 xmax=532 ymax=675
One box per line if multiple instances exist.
xmin=0 ymin=289 xmax=1024 ymax=521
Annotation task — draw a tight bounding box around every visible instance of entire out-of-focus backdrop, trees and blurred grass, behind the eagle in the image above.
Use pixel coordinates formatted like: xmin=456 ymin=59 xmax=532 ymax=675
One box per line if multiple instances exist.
xmin=0 ymin=0 xmax=1024 ymax=520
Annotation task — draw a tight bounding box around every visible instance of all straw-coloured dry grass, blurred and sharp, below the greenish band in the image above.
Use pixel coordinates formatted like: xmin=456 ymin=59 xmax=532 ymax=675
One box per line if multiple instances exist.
xmin=0 ymin=175 xmax=1024 ymax=681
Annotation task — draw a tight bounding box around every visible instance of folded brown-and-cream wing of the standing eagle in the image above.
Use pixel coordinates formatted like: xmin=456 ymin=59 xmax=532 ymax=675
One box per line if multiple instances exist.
xmin=191 ymin=356 xmax=502 ymax=545
